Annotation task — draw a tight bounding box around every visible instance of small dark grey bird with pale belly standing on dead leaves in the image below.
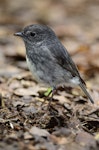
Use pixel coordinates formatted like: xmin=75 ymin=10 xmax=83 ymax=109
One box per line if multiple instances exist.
xmin=15 ymin=24 xmax=94 ymax=103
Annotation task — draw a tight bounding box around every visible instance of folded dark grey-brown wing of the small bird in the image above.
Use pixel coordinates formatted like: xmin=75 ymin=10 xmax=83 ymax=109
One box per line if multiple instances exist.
xmin=50 ymin=43 xmax=85 ymax=84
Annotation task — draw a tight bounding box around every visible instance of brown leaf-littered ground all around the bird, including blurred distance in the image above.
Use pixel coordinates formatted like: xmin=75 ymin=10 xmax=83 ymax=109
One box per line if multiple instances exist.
xmin=0 ymin=0 xmax=99 ymax=150
